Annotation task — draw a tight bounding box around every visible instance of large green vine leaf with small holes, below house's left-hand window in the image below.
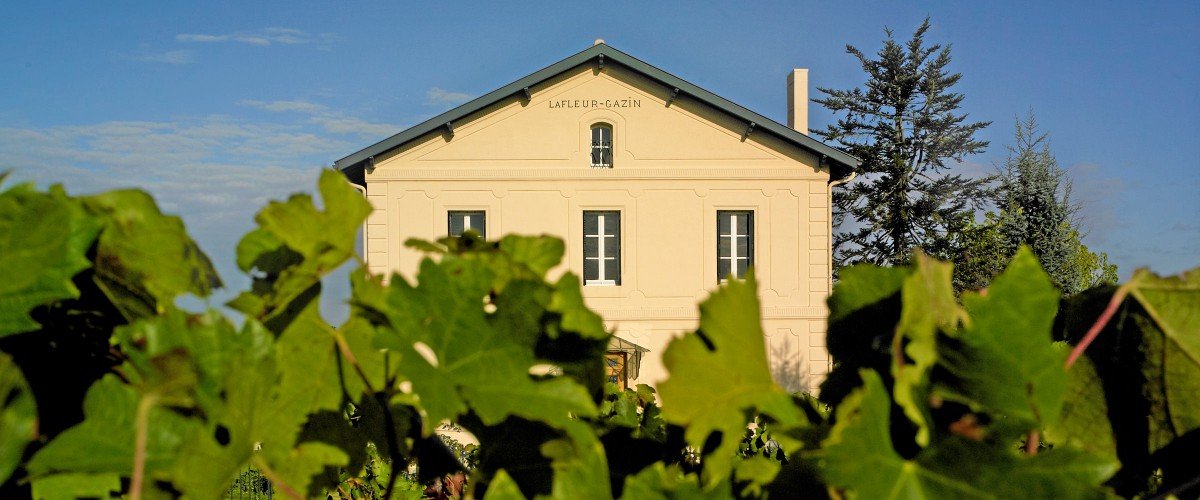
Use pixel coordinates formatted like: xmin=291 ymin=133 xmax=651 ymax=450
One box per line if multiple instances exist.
xmin=355 ymin=257 xmax=596 ymax=434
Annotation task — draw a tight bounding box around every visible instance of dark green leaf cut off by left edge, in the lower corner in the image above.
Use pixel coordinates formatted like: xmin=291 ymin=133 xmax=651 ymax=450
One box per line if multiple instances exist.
xmin=0 ymin=353 xmax=37 ymax=484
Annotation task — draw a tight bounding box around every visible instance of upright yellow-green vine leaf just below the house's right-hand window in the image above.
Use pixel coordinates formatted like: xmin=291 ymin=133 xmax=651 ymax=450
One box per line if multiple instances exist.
xmin=659 ymin=272 xmax=805 ymax=488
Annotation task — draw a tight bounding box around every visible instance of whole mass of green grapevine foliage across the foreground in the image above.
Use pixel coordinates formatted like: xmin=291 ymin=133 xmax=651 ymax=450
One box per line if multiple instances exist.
xmin=0 ymin=171 xmax=1200 ymax=499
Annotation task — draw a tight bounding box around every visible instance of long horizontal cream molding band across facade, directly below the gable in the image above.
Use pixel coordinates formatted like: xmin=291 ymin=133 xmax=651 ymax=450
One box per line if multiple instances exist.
xmin=367 ymin=167 xmax=826 ymax=183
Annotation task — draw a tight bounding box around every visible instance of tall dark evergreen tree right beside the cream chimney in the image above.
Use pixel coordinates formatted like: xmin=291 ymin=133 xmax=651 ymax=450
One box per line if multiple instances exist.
xmin=815 ymin=19 xmax=990 ymax=267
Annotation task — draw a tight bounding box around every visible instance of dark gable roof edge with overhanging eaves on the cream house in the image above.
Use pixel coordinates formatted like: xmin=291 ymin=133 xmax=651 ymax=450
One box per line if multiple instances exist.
xmin=334 ymin=42 xmax=862 ymax=182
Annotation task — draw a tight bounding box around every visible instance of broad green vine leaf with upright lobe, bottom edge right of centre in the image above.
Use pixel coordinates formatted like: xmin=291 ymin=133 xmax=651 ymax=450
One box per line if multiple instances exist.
xmin=823 ymin=371 xmax=1117 ymax=499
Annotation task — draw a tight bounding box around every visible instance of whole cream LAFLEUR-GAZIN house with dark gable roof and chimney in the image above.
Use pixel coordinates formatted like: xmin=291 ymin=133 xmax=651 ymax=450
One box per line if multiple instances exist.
xmin=335 ymin=41 xmax=858 ymax=390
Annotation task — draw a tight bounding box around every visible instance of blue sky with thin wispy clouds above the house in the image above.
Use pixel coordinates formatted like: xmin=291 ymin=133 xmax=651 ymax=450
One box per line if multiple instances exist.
xmin=0 ymin=0 xmax=1200 ymax=316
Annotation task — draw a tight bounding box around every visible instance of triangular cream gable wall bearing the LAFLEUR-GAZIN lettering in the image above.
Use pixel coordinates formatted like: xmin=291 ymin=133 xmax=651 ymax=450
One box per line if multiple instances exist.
xmin=377 ymin=66 xmax=815 ymax=169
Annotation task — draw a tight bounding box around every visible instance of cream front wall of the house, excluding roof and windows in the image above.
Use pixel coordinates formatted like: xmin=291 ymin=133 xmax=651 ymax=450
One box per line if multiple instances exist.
xmin=366 ymin=66 xmax=830 ymax=390
